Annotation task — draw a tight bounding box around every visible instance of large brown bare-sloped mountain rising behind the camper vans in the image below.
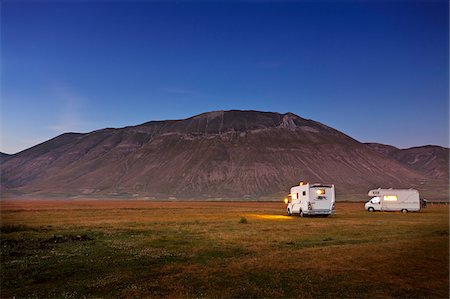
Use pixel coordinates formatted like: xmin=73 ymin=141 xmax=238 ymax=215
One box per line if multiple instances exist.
xmin=1 ymin=110 xmax=448 ymax=200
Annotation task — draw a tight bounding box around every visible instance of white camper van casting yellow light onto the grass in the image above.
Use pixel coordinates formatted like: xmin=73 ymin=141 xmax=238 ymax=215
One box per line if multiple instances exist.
xmin=285 ymin=182 xmax=335 ymax=217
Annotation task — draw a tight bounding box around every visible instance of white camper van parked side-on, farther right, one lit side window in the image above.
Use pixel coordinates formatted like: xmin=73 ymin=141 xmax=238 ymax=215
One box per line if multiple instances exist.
xmin=365 ymin=188 xmax=421 ymax=213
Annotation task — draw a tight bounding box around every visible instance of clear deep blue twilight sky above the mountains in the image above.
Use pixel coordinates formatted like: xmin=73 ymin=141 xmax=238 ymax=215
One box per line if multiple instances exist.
xmin=0 ymin=0 xmax=449 ymax=153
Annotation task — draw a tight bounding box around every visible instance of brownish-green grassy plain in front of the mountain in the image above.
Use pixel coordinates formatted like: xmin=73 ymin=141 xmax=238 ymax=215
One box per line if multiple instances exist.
xmin=0 ymin=201 xmax=449 ymax=298
